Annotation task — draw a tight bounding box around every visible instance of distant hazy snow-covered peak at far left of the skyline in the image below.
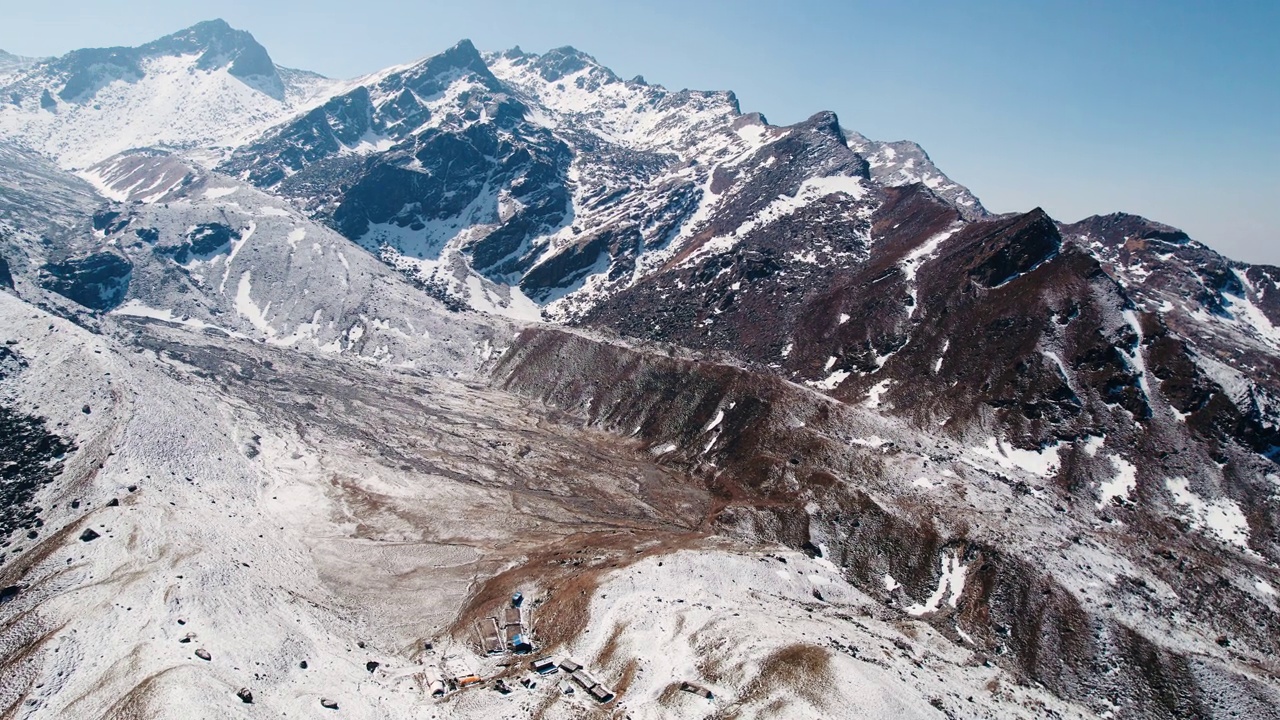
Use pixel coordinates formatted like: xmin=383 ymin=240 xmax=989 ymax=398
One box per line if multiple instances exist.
xmin=0 ymin=20 xmax=334 ymax=168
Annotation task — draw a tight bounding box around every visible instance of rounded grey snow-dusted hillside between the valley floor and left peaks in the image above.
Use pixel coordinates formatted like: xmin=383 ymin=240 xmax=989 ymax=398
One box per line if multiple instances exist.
xmin=0 ymin=151 xmax=509 ymax=375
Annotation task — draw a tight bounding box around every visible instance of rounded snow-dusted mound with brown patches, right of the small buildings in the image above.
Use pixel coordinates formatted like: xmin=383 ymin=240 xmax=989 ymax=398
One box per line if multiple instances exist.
xmin=445 ymin=541 xmax=1092 ymax=720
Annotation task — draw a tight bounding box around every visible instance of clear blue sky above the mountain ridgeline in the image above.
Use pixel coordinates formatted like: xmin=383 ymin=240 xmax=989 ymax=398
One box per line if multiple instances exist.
xmin=0 ymin=0 xmax=1280 ymax=264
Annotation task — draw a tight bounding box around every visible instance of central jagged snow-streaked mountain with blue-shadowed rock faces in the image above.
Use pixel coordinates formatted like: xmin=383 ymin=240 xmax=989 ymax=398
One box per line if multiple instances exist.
xmin=221 ymin=42 xmax=984 ymax=319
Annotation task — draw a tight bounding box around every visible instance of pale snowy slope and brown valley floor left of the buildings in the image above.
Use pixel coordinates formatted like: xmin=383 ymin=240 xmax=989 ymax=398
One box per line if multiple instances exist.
xmin=0 ymin=293 xmax=704 ymax=717
